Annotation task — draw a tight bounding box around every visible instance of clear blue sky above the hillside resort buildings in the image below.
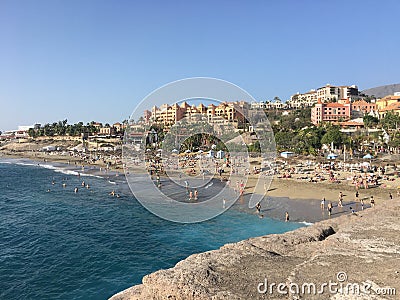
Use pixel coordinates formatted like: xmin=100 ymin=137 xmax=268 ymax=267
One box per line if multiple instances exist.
xmin=0 ymin=0 xmax=400 ymax=130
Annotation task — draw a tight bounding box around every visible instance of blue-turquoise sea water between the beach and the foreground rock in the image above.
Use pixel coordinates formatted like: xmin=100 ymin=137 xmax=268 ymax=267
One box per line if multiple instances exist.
xmin=0 ymin=159 xmax=304 ymax=299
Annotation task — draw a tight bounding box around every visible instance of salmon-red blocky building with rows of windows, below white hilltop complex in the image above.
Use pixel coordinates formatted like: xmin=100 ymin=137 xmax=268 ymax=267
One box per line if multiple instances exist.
xmin=311 ymin=99 xmax=351 ymax=125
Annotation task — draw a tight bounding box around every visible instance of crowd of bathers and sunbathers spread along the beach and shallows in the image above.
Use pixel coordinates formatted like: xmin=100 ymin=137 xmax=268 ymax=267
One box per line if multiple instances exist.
xmin=41 ymin=148 xmax=400 ymax=221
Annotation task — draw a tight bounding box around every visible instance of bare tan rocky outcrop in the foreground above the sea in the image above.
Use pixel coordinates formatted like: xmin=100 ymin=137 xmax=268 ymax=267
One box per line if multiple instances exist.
xmin=111 ymin=200 xmax=400 ymax=300
